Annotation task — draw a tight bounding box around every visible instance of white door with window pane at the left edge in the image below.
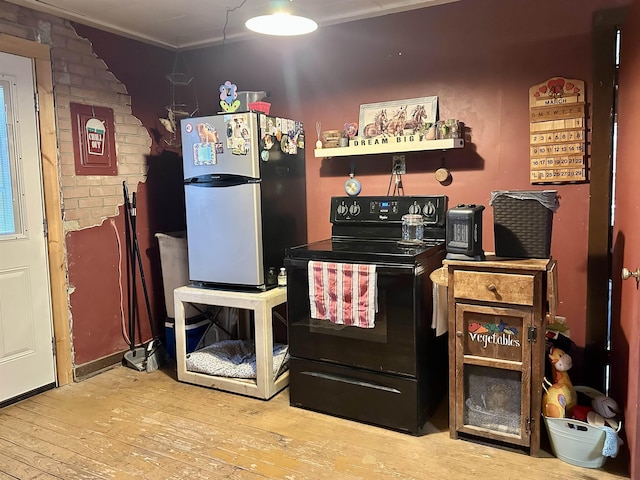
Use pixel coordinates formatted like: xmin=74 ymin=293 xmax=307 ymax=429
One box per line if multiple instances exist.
xmin=0 ymin=52 xmax=56 ymax=402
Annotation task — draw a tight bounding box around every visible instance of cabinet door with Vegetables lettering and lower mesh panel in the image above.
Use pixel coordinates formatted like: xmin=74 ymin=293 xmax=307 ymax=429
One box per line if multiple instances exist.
xmin=456 ymin=303 xmax=532 ymax=446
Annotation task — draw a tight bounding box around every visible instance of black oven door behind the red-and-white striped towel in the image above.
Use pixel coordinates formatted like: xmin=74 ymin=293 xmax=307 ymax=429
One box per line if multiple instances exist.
xmin=285 ymin=257 xmax=424 ymax=377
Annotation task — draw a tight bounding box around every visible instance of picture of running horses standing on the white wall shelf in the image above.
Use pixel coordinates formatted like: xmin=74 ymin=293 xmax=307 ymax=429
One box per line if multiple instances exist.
xmin=358 ymin=96 xmax=438 ymax=138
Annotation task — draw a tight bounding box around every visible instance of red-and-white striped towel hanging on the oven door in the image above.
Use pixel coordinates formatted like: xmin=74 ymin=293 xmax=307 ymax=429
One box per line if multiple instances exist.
xmin=308 ymin=260 xmax=378 ymax=328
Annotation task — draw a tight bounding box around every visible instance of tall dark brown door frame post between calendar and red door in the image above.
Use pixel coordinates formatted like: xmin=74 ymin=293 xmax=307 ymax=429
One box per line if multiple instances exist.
xmin=584 ymin=8 xmax=626 ymax=393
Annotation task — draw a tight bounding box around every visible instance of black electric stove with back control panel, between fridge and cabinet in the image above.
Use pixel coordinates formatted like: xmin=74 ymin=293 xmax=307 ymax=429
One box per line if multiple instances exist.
xmin=285 ymin=196 xmax=448 ymax=434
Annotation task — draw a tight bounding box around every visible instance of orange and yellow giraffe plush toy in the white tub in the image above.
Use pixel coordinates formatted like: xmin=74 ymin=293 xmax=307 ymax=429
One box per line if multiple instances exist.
xmin=542 ymin=347 xmax=577 ymax=418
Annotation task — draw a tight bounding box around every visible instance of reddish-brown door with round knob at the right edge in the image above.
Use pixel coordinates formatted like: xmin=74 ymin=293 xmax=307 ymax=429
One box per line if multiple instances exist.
xmin=611 ymin=0 xmax=640 ymax=474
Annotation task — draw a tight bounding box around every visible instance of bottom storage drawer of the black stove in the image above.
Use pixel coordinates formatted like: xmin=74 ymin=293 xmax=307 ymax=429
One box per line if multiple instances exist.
xmin=289 ymin=357 xmax=436 ymax=435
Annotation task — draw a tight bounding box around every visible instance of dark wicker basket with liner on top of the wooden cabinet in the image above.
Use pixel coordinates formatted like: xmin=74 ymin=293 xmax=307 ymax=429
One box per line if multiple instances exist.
xmin=491 ymin=190 xmax=557 ymax=258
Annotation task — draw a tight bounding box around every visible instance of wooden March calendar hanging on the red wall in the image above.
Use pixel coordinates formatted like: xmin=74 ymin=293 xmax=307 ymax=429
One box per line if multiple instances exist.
xmin=529 ymin=77 xmax=587 ymax=184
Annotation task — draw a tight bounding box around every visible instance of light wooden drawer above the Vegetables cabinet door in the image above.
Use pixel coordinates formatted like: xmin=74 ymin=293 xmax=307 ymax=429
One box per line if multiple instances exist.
xmin=453 ymin=270 xmax=535 ymax=305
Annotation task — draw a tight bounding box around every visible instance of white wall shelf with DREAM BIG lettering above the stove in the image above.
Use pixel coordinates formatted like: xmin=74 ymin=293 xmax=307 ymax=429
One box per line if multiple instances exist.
xmin=313 ymin=137 xmax=464 ymax=158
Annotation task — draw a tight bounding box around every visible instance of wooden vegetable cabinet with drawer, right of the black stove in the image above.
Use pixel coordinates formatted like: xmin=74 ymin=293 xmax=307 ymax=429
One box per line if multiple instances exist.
xmin=444 ymin=255 xmax=555 ymax=455
